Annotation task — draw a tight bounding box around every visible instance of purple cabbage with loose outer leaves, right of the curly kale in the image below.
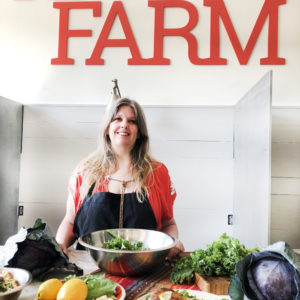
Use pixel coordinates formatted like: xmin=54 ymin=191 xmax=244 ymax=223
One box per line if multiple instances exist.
xmin=228 ymin=242 xmax=300 ymax=300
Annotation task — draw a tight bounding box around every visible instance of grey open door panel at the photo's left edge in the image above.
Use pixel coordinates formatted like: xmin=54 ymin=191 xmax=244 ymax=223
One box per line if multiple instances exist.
xmin=0 ymin=97 xmax=23 ymax=244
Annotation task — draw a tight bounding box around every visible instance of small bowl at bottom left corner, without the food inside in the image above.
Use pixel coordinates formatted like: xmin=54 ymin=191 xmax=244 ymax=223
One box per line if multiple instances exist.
xmin=0 ymin=267 xmax=32 ymax=300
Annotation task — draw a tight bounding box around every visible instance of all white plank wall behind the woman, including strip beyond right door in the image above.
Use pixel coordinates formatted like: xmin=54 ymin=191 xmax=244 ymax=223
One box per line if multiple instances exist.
xmin=19 ymin=105 xmax=300 ymax=250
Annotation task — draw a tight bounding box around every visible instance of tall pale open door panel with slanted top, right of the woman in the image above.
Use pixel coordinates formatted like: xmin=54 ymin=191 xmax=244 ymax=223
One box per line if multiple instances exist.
xmin=233 ymin=72 xmax=272 ymax=247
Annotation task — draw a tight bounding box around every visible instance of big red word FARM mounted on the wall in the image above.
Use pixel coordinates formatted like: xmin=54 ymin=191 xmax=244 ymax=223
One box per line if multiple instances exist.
xmin=51 ymin=0 xmax=286 ymax=65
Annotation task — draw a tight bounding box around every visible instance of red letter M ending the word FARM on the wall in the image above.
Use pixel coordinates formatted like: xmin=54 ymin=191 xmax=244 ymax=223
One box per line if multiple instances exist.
xmin=204 ymin=0 xmax=286 ymax=65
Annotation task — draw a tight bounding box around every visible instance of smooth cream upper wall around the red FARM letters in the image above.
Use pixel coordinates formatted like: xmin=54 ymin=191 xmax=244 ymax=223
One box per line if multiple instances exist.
xmin=0 ymin=0 xmax=300 ymax=106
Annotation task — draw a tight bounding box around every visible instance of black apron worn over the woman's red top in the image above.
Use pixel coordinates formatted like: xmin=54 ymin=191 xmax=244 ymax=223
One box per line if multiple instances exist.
xmin=73 ymin=186 xmax=157 ymax=238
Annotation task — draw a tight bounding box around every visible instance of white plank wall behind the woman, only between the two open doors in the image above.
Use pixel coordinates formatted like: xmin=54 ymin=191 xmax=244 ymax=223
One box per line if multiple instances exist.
xmin=19 ymin=105 xmax=233 ymax=251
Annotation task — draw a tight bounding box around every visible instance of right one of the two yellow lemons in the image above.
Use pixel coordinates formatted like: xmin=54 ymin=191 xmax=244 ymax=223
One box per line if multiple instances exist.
xmin=56 ymin=278 xmax=87 ymax=300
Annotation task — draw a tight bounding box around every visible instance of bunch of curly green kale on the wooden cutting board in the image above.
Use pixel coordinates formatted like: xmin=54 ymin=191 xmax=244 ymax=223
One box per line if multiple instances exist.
xmin=171 ymin=233 xmax=258 ymax=283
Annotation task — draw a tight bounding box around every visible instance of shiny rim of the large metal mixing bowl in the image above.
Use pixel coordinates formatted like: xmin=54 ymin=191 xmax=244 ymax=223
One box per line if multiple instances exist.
xmin=78 ymin=228 xmax=178 ymax=254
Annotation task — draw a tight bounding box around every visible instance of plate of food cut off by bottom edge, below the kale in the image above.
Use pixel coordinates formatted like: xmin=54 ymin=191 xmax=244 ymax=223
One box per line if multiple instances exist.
xmin=138 ymin=288 xmax=230 ymax=300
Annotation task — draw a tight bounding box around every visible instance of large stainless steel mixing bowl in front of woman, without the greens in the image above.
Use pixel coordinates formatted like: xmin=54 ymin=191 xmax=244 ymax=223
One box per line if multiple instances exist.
xmin=79 ymin=228 xmax=178 ymax=276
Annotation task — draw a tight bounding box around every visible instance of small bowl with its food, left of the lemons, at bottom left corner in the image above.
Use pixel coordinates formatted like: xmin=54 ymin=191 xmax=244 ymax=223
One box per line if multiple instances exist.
xmin=0 ymin=268 xmax=32 ymax=300
